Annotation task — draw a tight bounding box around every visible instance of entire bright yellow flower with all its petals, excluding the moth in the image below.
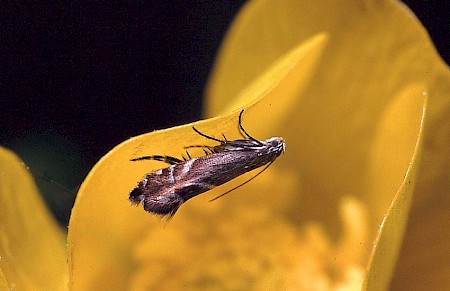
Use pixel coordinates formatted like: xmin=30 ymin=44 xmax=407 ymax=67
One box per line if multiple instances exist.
xmin=0 ymin=0 xmax=450 ymax=290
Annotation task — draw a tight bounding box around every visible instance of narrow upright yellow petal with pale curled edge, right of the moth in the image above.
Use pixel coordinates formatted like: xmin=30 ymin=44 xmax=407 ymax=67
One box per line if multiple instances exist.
xmin=364 ymin=85 xmax=425 ymax=290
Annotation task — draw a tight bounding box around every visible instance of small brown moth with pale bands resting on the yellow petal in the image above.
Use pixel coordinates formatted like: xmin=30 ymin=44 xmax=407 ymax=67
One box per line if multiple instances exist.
xmin=129 ymin=110 xmax=286 ymax=218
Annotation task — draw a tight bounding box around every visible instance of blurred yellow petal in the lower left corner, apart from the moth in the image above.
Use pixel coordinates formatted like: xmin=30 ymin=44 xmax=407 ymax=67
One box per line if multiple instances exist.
xmin=0 ymin=147 xmax=68 ymax=290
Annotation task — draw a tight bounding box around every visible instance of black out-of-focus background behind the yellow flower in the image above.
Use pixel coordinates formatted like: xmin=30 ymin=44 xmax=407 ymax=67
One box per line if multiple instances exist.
xmin=0 ymin=1 xmax=450 ymax=225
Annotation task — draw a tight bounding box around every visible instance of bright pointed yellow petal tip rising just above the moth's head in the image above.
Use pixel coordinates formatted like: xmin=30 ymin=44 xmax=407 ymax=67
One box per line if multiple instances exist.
xmin=207 ymin=33 xmax=328 ymax=120
